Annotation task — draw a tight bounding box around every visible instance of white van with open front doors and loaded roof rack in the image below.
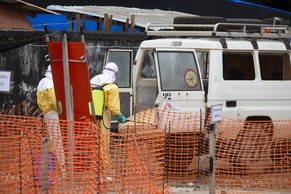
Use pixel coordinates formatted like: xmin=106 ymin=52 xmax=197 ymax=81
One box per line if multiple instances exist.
xmin=106 ymin=17 xmax=291 ymax=135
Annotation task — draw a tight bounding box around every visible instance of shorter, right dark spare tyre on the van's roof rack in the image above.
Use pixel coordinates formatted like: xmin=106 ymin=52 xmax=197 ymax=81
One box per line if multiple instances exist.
xmin=226 ymin=18 xmax=263 ymax=33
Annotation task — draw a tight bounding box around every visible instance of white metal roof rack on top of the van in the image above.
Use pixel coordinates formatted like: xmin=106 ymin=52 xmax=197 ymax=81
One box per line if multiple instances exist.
xmin=145 ymin=23 xmax=291 ymax=39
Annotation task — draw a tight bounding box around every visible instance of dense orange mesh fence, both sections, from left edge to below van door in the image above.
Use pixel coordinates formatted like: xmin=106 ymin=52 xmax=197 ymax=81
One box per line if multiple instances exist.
xmin=0 ymin=111 xmax=169 ymax=193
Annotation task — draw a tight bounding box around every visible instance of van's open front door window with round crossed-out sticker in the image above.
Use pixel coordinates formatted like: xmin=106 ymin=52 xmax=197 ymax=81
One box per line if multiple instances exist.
xmin=157 ymin=51 xmax=201 ymax=91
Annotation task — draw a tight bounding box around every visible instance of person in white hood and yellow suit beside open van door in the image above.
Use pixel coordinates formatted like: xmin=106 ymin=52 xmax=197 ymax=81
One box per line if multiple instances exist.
xmin=90 ymin=62 xmax=126 ymax=184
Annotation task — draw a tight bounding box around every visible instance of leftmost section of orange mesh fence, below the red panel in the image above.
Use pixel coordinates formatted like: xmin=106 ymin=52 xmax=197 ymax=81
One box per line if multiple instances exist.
xmin=0 ymin=115 xmax=102 ymax=193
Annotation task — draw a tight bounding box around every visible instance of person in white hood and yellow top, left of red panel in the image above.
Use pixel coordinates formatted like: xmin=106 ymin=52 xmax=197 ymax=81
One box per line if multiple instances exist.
xmin=36 ymin=65 xmax=66 ymax=177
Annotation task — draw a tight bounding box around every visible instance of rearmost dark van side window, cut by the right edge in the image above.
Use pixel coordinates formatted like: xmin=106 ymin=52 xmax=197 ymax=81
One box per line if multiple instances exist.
xmin=259 ymin=53 xmax=291 ymax=80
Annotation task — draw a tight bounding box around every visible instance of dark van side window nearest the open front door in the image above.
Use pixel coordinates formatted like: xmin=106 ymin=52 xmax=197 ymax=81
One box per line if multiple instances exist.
xmin=223 ymin=52 xmax=255 ymax=80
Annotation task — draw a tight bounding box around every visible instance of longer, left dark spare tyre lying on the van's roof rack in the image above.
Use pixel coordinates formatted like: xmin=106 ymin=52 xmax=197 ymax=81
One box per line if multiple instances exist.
xmin=173 ymin=16 xmax=226 ymax=31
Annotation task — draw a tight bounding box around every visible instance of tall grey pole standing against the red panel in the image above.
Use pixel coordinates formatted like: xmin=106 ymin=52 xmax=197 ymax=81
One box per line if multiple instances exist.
xmin=62 ymin=33 xmax=75 ymax=181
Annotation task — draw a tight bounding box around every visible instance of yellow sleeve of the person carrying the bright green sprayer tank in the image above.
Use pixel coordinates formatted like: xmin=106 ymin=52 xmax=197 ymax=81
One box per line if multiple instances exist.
xmin=103 ymin=84 xmax=120 ymax=115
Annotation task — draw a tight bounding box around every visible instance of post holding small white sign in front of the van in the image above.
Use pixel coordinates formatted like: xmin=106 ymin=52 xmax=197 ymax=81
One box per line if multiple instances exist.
xmin=209 ymin=123 xmax=218 ymax=194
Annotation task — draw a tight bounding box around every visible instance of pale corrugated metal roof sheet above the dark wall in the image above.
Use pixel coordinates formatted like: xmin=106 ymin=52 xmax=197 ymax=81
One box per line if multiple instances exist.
xmin=47 ymin=5 xmax=198 ymax=28
